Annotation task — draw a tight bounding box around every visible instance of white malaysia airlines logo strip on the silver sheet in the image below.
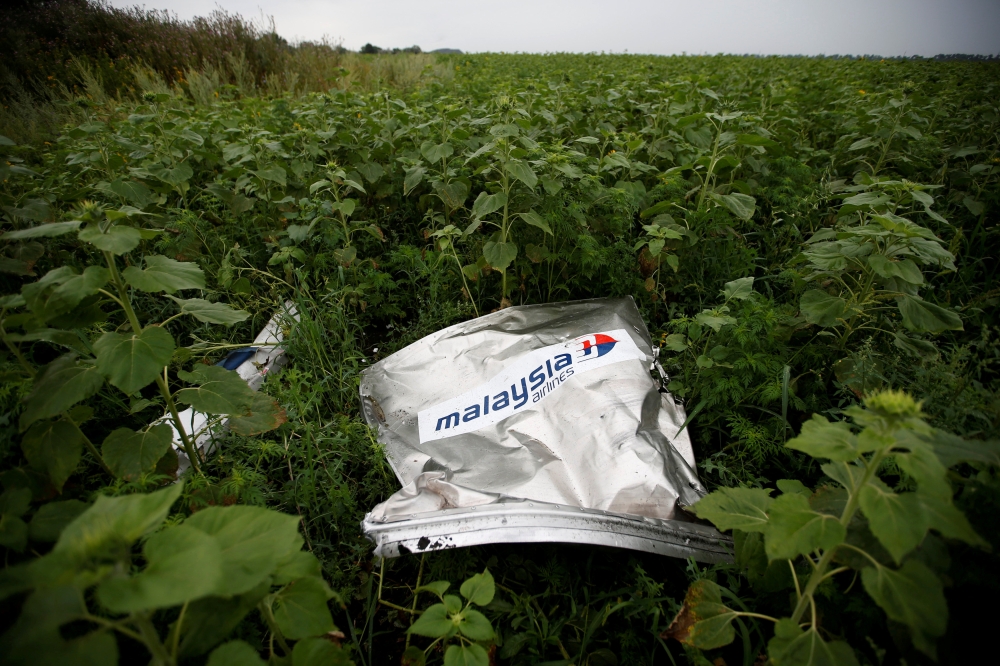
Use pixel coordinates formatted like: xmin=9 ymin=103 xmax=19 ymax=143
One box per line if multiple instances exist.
xmin=417 ymin=329 xmax=649 ymax=442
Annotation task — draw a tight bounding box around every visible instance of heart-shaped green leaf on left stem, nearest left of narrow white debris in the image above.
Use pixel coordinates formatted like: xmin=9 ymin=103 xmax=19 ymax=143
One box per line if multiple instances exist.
xmin=94 ymin=326 xmax=174 ymax=395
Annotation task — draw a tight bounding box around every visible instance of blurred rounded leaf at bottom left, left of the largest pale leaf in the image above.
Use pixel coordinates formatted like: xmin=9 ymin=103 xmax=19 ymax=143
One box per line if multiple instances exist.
xmin=97 ymin=524 xmax=223 ymax=613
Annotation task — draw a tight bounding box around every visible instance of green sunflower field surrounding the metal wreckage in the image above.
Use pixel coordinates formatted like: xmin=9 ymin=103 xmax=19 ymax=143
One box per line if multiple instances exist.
xmin=0 ymin=39 xmax=1000 ymax=666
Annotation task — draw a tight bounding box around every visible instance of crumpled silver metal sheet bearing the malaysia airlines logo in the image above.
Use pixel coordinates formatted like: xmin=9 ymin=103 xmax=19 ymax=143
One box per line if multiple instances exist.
xmin=361 ymin=298 xmax=732 ymax=561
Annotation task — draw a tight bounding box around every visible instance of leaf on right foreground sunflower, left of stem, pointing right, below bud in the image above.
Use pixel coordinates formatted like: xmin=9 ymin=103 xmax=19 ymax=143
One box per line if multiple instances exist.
xmin=764 ymin=493 xmax=847 ymax=560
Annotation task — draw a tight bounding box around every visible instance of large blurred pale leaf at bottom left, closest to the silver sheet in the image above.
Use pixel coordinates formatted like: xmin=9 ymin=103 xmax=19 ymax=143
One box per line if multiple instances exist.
xmin=184 ymin=506 xmax=302 ymax=595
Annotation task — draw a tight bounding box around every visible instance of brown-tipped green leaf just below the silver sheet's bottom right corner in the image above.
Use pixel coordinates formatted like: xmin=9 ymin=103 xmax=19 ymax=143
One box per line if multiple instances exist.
xmin=663 ymin=578 xmax=737 ymax=650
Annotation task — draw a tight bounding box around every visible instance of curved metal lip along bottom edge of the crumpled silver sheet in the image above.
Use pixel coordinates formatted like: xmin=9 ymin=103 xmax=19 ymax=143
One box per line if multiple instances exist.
xmin=361 ymin=499 xmax=733 ymax=563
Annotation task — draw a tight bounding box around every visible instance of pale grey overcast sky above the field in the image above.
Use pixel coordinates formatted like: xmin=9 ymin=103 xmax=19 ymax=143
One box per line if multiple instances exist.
xmin=111 ymin=0 xmax=1000 ymax=56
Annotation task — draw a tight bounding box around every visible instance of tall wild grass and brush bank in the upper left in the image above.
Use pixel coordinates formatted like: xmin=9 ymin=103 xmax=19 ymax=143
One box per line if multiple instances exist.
xmin=0 ymin=0 xmax=453 ymax=143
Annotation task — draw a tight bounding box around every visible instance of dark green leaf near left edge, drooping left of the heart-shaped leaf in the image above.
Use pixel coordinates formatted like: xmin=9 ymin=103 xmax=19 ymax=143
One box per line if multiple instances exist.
xmin=20 ymin=354 xmax=104 ymax=430
